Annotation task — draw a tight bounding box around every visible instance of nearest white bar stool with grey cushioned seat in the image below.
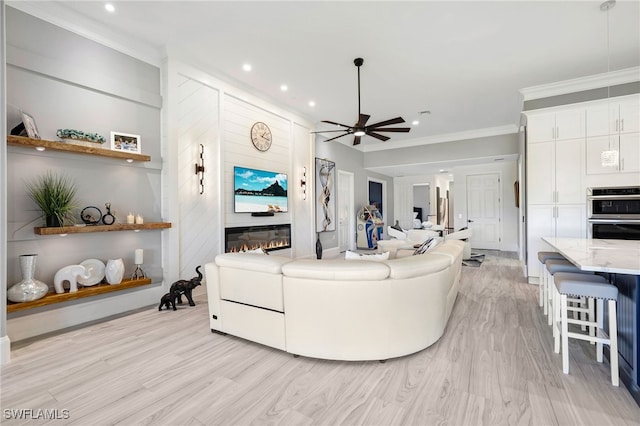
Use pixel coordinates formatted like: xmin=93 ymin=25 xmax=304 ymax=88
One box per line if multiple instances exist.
xmin=553 ymin=272 xmax=620 ymax=386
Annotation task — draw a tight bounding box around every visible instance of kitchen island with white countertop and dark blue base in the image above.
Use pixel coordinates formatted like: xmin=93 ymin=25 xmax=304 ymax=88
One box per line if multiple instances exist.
xmin=542 ymin=237 xmax=640 ymax=405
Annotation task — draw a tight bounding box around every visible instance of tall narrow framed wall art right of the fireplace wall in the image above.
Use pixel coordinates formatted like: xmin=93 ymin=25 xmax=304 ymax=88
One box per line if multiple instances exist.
xmin=316 ymin=158 xmax=336 ymax=232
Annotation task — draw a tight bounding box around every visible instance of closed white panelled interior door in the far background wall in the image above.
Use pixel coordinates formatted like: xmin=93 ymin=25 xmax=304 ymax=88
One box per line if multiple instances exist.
xmin=467 ymin=173 xmax=502 ymax=250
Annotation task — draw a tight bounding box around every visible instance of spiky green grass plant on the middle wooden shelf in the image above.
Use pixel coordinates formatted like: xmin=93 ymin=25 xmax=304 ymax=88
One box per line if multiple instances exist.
xmin=27 ymin=170 xmax=77 ymax=226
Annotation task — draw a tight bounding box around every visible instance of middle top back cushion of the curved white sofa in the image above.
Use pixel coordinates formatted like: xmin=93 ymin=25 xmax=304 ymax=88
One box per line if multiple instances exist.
xmin=282 ymin=259 xmax=389 ymax=281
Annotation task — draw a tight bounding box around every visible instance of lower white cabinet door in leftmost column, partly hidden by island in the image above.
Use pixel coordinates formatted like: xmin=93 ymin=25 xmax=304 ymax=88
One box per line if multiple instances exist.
xmin=527 ymin=205 xmax=555 ymax=277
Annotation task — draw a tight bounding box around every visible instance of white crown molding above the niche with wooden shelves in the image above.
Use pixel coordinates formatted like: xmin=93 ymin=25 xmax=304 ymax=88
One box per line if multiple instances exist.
xmin=5 ymin=1 xmax=166 ymax=67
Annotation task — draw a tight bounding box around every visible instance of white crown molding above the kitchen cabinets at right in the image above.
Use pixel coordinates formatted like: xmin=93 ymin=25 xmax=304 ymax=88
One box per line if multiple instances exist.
xmin=520 ymin=67 xmax=640 ymax=101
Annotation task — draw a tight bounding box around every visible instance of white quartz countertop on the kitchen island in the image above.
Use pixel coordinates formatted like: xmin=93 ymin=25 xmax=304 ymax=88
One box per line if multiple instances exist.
xmin=542 ymin=237 xmax=640 ymax=275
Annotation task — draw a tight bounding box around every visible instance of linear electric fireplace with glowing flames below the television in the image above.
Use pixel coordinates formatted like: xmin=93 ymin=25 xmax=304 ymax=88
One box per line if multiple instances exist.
xmin=224 ymin=223 xmax=291 ymax=253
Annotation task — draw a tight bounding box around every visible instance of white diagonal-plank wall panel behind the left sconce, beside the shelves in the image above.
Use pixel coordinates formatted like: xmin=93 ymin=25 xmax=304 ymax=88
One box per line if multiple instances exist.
xmin=177 ymin=74 xmax=223 ymax=279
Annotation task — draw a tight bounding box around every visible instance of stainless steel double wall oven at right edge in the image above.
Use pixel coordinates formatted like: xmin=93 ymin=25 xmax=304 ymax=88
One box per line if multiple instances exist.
xmin=587 ymin=186 xmax=640 ymax=240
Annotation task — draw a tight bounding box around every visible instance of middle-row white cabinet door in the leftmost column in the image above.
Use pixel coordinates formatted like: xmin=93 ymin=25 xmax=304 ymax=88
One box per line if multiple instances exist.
xmin=527 ymin=141 xmax=556 ymax=204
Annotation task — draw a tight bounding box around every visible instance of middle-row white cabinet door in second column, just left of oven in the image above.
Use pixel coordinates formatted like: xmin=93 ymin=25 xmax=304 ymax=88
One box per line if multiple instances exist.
xmin=555 ymin=138 xmax=586 ymax=204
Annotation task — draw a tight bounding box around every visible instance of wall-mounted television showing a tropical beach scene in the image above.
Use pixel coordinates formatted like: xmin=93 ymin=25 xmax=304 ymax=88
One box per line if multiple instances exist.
xmin=233 ymin=166 xmax=288 ymax=213
